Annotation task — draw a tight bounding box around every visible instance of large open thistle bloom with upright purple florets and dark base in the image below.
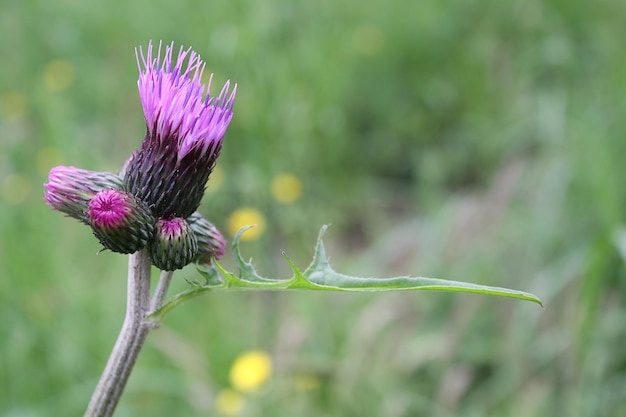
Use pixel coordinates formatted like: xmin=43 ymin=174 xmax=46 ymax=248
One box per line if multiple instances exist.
xmin=124 ymin=43 xmax=237 ymax=218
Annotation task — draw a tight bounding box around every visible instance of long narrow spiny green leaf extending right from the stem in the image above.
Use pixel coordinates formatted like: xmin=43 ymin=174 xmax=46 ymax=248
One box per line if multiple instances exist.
xmin=150 ymin=225 xmax=541 ymax=321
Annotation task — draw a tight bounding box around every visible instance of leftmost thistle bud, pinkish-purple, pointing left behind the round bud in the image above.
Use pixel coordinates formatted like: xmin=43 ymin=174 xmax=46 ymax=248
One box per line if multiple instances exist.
xmin=44 ymin=166 xmax=122 ymax=224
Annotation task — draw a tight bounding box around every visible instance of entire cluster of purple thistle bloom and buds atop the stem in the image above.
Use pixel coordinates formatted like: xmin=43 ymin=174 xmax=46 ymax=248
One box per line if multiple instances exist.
xmin=44 ymin=42 xmax=237 ymax=271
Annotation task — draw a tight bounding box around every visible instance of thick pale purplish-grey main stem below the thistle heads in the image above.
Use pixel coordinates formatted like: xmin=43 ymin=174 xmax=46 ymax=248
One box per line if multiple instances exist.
xmin=84 ymin=249 xmax=154 ymax=417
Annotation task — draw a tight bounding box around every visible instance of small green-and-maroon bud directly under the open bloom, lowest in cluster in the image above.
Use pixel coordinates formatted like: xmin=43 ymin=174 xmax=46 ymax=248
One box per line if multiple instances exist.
xmin=148 ymin=217 xmax=198 ymax=271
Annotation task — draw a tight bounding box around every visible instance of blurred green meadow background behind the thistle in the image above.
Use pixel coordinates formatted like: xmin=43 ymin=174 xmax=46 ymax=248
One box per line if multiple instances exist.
xmin=0 ymin=0 xmax=626 ymax=417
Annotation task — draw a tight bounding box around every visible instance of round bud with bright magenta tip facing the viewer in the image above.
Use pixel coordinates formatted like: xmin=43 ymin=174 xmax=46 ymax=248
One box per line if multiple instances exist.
xmin=86 ymin=190 xmax=155 ymax=253
